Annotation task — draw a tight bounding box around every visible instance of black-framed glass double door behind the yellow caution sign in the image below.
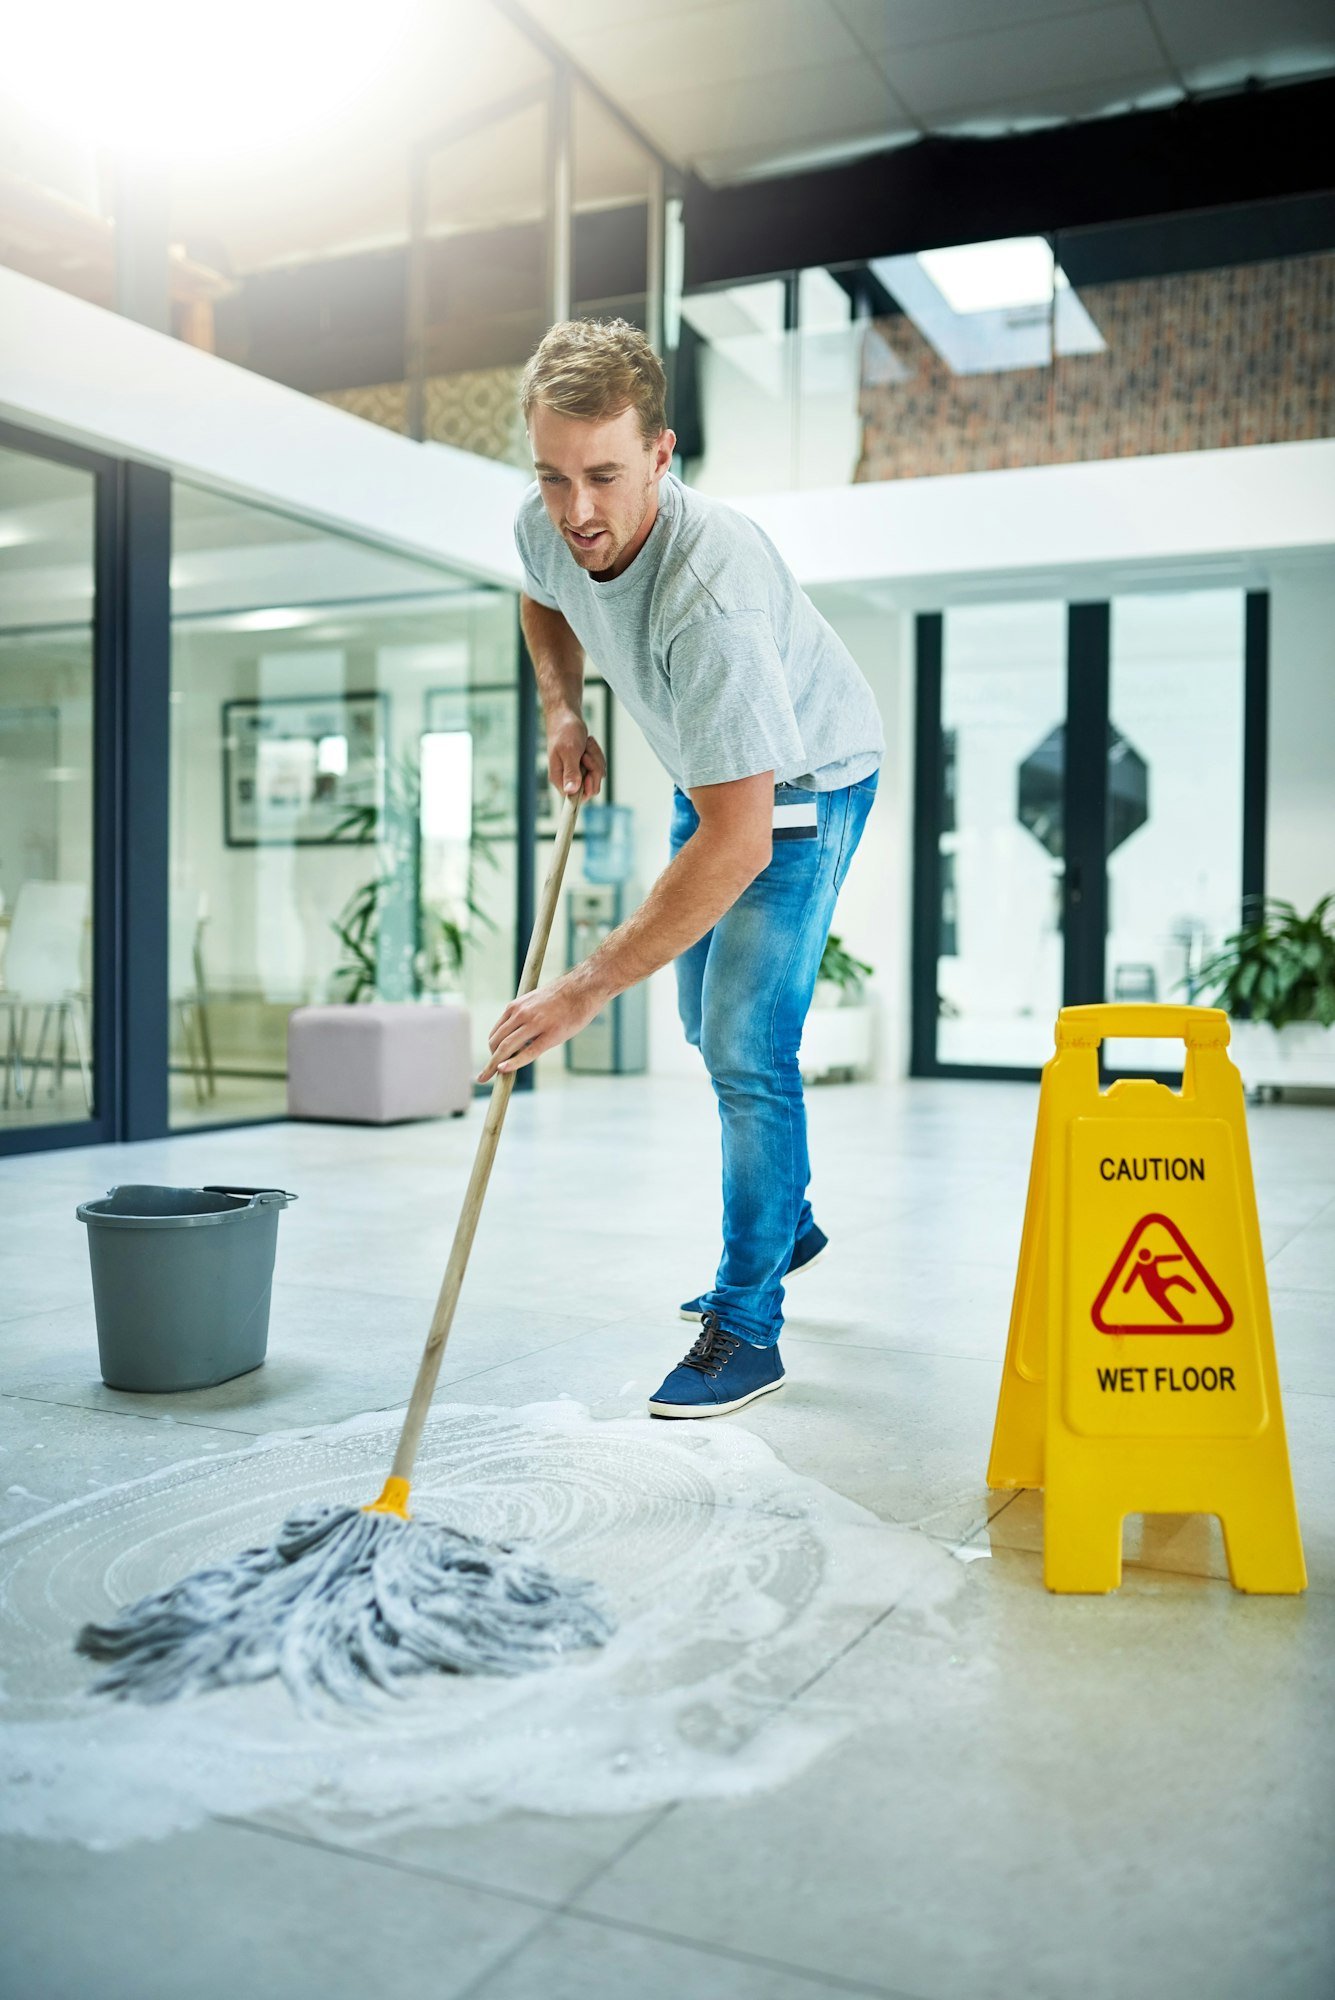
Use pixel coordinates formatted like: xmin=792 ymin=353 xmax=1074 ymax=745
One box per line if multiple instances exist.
xmin=911 ymin=590 xmax=1265 ymax=1076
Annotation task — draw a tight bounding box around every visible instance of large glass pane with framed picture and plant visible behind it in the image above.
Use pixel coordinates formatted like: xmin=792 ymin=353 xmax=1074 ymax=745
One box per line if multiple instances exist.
xmin=170 ymin=482 xmax=518 ymax=1126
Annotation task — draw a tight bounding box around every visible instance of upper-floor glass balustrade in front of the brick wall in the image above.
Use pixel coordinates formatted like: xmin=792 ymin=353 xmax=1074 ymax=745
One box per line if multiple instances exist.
xmin=677 ymin=202 xmax=1335 ymax=494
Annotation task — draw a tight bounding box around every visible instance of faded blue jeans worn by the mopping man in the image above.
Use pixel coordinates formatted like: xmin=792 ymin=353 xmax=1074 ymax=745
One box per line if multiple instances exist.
xmin=671 ymin=772 xmax=875 ymax=1348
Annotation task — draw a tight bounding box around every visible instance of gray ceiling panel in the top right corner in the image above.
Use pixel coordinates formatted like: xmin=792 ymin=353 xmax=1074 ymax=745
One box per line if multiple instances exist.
xmin=1151 ymin=0 xmax=1335 ymax=90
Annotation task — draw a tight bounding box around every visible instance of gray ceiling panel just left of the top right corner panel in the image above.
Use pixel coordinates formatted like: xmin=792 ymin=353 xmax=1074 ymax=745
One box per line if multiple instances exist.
xmin=885 ymin=4 xmax=1175 ymax=122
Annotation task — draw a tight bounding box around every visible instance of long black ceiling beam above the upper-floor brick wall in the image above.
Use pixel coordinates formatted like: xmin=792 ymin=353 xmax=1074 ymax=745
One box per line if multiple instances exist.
xmin=685 ymin=78 xmax=1335 ymax=288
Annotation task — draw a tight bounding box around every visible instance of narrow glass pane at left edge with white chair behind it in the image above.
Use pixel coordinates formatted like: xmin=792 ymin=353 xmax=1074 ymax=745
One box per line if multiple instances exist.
xmin=0 ymin=450 xmax=96 ymax=1130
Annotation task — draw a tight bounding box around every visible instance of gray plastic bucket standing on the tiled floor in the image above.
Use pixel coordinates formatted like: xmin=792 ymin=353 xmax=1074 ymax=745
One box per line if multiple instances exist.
xmin=76 ymin=1186 xmax=296 ymax=1390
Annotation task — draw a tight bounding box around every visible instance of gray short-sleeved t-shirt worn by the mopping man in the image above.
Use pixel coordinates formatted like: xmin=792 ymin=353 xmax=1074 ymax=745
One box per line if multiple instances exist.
xmin=514 ymin=472 xmax=885 ymax=792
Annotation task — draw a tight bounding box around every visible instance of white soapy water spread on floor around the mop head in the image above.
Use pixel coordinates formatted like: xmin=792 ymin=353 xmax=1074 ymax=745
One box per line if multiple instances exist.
xmin=0 ymin=1400 xmax=961 ymax=1848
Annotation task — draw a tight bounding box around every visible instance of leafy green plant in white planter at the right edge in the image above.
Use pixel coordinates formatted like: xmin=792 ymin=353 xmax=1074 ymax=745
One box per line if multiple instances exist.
xmin=1193 ymin=892 xmax=1335 ymax=1092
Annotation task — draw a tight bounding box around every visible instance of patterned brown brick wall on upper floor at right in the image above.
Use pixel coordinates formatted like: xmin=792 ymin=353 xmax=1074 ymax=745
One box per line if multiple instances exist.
xmin=855 ymin=254 xmax=1335 ymax=480
